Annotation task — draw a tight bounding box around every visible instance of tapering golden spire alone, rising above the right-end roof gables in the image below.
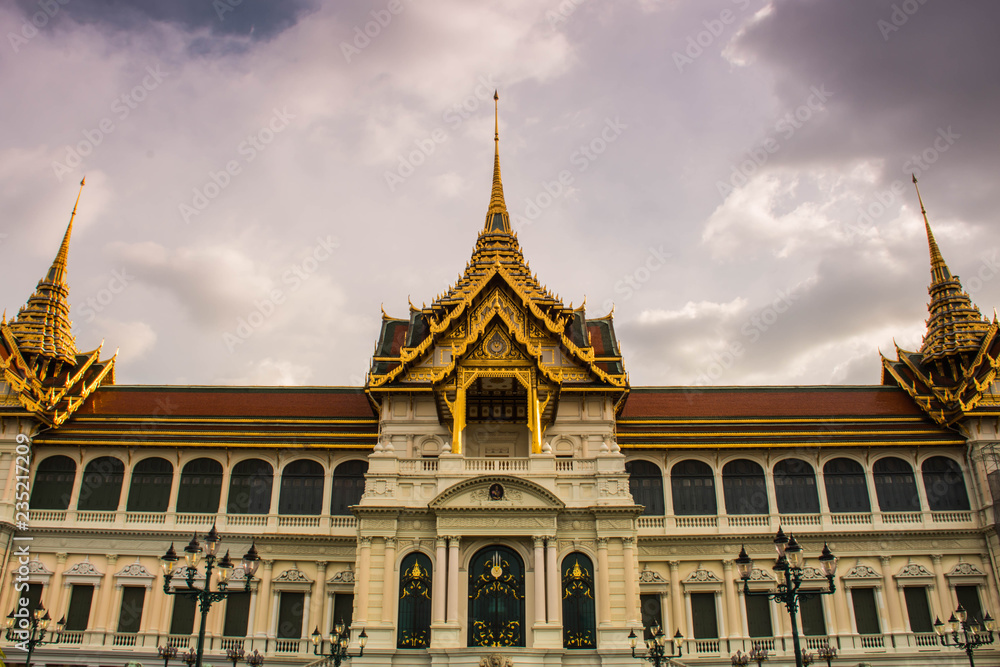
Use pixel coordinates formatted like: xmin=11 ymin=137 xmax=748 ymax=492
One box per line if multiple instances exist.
xmin=913 ymin=175 xmax=989 ymax=368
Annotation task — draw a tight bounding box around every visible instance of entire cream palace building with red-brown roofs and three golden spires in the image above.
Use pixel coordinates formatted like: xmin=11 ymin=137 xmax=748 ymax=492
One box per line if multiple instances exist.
xmin=0 ymin=107 xmax=1000 ymax=667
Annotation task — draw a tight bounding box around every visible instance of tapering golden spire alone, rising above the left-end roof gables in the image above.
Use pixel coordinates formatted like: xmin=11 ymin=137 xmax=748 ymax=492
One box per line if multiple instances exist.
xmin=10 ymin=179 xmax=86 ymax=364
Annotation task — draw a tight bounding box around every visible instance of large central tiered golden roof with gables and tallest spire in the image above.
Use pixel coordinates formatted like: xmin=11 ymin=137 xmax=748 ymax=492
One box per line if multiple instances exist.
xmin=368 ymin=93 xmax=628 ymax=390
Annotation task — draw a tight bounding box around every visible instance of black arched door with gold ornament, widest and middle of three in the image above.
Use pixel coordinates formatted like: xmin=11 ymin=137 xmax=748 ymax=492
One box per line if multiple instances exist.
xmin=468 ymin=546 xmax=524 ymax=646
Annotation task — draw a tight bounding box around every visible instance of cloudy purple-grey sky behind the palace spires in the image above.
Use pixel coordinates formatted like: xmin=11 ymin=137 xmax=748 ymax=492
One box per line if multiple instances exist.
xmin=0 ymin=0 xmax=1000 ymax=385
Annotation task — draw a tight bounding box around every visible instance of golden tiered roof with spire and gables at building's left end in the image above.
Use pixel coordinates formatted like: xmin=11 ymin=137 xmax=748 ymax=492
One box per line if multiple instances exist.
xmin=0 ymin=181 xmax=115 ymax=426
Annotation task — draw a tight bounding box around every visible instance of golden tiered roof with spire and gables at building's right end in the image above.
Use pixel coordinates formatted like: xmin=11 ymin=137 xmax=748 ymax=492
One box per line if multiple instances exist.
xmin=882 ymin=177 xmax=1000 ymax=424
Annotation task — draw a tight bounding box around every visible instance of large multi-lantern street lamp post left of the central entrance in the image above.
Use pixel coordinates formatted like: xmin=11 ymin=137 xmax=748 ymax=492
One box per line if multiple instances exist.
xmin=160 ymin=525 xmax=260 ymax=667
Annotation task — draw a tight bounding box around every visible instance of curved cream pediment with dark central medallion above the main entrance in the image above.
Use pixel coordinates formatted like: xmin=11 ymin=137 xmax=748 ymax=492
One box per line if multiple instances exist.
xmin=430 ymin=475 xmax=566 ymax=510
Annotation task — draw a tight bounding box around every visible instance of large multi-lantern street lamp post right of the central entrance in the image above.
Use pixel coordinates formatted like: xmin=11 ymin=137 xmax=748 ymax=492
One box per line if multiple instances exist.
xmin=735 ymin=526 xmax=837 ymax=667
